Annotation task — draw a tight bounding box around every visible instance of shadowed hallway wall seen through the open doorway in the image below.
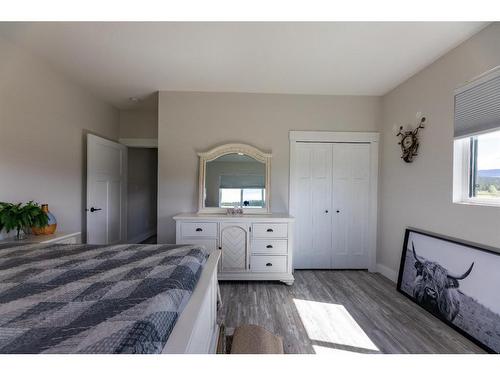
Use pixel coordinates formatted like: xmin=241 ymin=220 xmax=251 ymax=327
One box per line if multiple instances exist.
xmin=127 ymin=147 xmax=158 ymax=243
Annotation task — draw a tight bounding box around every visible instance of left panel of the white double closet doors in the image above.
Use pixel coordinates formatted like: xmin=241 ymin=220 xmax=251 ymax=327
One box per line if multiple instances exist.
xmin=294 ymin=143 xmax=332 ymax=269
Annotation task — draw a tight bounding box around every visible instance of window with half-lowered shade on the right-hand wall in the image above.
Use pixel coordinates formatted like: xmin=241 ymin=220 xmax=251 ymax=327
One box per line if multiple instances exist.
xmin=453 ymin=66 xmax=500 ymax=206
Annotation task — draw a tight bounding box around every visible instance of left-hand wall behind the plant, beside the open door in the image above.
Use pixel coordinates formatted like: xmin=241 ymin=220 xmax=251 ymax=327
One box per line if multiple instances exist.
xmin=0 ymin=33 xmax=118 ymax=236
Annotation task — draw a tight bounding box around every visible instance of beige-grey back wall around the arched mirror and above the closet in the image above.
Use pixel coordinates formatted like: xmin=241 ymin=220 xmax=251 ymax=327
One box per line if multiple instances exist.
xmin=158 ymin=92 xmax=381 ymax=242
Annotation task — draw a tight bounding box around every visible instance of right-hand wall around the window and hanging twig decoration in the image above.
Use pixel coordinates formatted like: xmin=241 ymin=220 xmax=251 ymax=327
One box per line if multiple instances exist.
xmin=377 ymin=23 xmax=500 ymax=273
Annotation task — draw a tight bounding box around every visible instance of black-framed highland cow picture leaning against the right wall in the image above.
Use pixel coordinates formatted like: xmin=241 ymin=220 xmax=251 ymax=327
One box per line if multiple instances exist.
xmin=397 ymin=229 xmax=500 ymax=353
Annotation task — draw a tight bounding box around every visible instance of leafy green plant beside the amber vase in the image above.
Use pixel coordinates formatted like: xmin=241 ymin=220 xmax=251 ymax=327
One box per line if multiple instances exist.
xmin=0 ymin=201 xmax=49 ymax=240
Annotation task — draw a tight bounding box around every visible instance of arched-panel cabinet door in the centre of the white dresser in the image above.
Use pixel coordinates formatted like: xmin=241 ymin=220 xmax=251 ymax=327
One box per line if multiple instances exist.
xmin=220 ymin=223 xmax=248 ymax=272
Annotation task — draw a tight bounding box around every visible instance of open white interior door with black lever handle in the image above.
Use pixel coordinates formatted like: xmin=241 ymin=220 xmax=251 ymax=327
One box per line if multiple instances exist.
xmin=87 ymin=134 xmax=127 ymax=244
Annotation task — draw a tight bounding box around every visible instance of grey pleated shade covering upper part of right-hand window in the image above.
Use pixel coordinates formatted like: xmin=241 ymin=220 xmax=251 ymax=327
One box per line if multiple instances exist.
xmin=454 ymin=67 xmax=500 ymax=138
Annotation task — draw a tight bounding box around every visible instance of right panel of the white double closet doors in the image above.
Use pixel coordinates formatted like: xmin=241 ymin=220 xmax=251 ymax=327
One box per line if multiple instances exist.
xmin=332 ymin=143 xmax=370 ymax=269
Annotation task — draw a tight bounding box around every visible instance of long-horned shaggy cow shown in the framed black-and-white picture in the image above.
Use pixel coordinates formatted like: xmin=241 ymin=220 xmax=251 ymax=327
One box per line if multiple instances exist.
xmin=411 ymin=242 xmax=474 ymax=322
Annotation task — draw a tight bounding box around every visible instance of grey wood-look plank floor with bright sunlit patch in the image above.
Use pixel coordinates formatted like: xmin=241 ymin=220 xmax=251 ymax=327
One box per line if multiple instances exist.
xmin=220 ymin=270 xmax=483 ymax=353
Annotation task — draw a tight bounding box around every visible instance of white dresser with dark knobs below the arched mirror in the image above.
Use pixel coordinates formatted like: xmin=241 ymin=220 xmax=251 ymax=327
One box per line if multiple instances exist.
xmin=174 ymin=213 xmax=294 ymax=285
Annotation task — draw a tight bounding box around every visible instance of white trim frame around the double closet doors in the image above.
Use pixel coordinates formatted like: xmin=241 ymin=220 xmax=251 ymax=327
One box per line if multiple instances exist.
xmin=288 ymin=130 xmax=380 ymax=272
